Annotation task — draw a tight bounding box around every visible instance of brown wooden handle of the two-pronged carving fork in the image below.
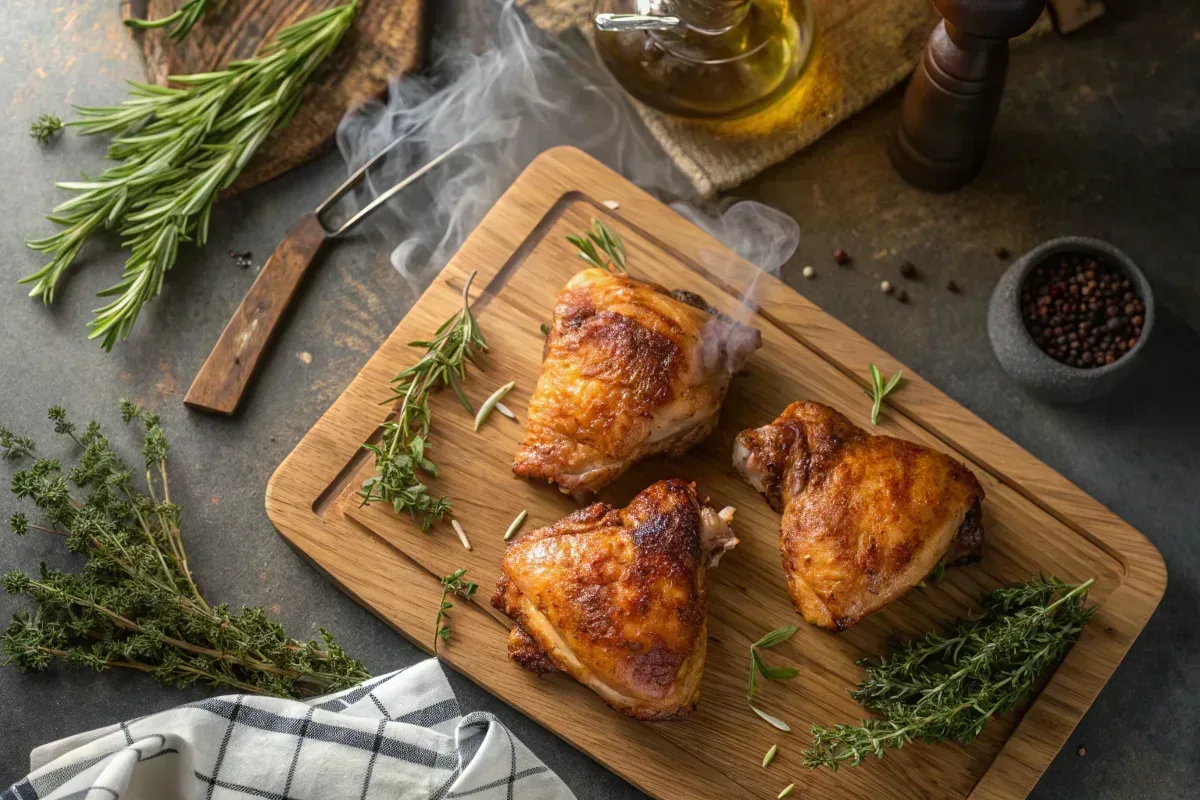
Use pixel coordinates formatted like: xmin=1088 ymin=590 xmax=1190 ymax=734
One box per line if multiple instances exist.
xmin=184 ymin=213 xmax=326 ymax=415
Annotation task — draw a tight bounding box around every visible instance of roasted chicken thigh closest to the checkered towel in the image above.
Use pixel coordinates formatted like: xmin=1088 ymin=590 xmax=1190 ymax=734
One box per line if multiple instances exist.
xmin=492 ymin=480 xmax=738 ymax=721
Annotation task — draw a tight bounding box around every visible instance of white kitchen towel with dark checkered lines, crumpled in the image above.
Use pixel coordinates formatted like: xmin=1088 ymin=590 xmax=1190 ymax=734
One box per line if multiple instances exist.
xmin=0 ymin=658 xmax=575 ymax=800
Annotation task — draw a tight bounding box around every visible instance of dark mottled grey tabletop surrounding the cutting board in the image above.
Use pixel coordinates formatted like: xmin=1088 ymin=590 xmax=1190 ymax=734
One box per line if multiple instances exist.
xmin=0 ymin=0 xmax=1200 ymax=800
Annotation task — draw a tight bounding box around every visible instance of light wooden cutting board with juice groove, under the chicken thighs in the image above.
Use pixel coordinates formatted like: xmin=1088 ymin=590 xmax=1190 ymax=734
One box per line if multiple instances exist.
xmin=266 ymin=149 xmax=1166 ymax=800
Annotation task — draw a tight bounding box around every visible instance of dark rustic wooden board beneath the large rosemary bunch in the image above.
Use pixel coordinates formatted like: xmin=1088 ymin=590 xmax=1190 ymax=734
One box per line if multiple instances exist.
xmin=121 ymin=0 xmax=425 ymax=192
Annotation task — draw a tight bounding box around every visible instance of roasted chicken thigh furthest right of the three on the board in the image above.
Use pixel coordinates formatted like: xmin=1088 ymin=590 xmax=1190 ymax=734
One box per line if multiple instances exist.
xmin=733 ymin=402 xmax=983 ymax=631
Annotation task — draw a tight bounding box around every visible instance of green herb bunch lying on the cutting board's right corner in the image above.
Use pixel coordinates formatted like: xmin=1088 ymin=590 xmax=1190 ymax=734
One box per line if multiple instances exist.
xmin=804 ymin=577 xmax=1096 ymax=770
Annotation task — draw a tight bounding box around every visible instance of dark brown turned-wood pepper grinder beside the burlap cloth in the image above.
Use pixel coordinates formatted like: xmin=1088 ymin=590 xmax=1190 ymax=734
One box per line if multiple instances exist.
xmin=888 ymin=0 xmax=1045 ymax=192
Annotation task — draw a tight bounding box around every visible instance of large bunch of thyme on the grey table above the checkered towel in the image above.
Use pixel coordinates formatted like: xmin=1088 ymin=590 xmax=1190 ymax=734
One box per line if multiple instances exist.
xmin=0 ymin=401 xmax=370 ymax=697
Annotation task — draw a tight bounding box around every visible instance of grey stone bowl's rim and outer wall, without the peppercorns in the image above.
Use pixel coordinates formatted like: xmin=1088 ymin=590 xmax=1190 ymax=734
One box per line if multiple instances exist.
xmin=988 ymin=236 xmax=1154 ymax=403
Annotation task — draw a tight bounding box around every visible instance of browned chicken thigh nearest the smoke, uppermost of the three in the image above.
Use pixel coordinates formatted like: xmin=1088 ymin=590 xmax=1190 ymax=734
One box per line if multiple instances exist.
xmin=512 ymin=269 xmax=761 ymax=499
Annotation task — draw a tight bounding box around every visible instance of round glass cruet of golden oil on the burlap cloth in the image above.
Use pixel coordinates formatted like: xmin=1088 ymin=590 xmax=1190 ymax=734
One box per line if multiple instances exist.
xmin=594 ymin=0 xmax=812 ymax=118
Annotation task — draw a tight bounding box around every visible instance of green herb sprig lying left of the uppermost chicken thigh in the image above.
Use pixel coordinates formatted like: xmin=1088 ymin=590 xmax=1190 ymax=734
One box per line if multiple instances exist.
xmin=359 ymin=272 xmax=487 ymax=530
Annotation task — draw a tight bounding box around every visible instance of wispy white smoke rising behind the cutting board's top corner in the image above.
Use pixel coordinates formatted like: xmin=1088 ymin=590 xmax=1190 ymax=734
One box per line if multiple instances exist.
xmin=337 ymin=0 xmax=798 ymax=309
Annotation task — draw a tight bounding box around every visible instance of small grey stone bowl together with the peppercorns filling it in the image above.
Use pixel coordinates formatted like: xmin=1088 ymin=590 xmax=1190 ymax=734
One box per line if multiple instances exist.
xmin=988 ymin=236 xmax=1154 ymax=402
